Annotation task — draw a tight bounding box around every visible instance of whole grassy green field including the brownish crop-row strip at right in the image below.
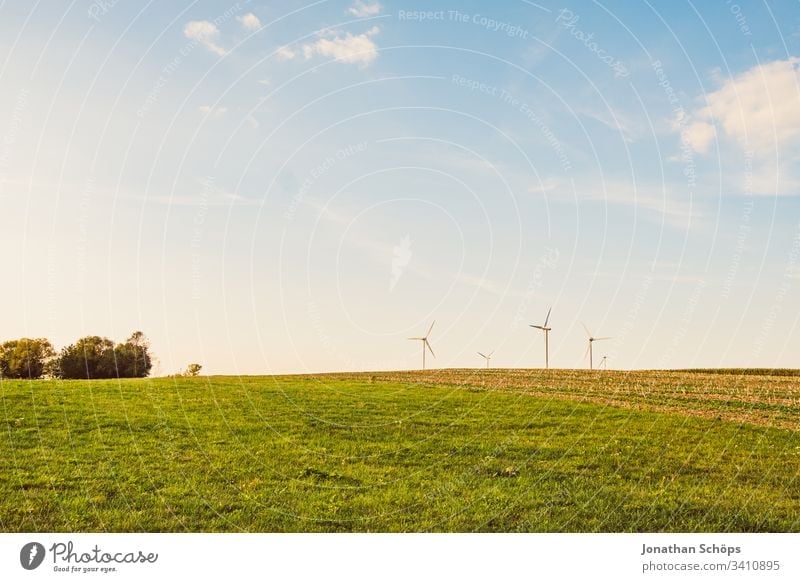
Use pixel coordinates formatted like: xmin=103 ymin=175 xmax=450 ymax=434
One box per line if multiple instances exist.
xmin=0 ymin=370 xmax=800 ymax=532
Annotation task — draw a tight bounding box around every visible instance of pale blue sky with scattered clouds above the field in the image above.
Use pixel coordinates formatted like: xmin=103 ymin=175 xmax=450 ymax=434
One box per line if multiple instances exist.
xmin=0 ymin=0 xmax=800 ymax=374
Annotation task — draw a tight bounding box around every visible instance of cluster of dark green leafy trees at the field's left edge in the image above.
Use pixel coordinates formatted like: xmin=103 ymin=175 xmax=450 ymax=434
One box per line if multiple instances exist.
xmin=0 ymin=331 xmax=153 ymax=380
